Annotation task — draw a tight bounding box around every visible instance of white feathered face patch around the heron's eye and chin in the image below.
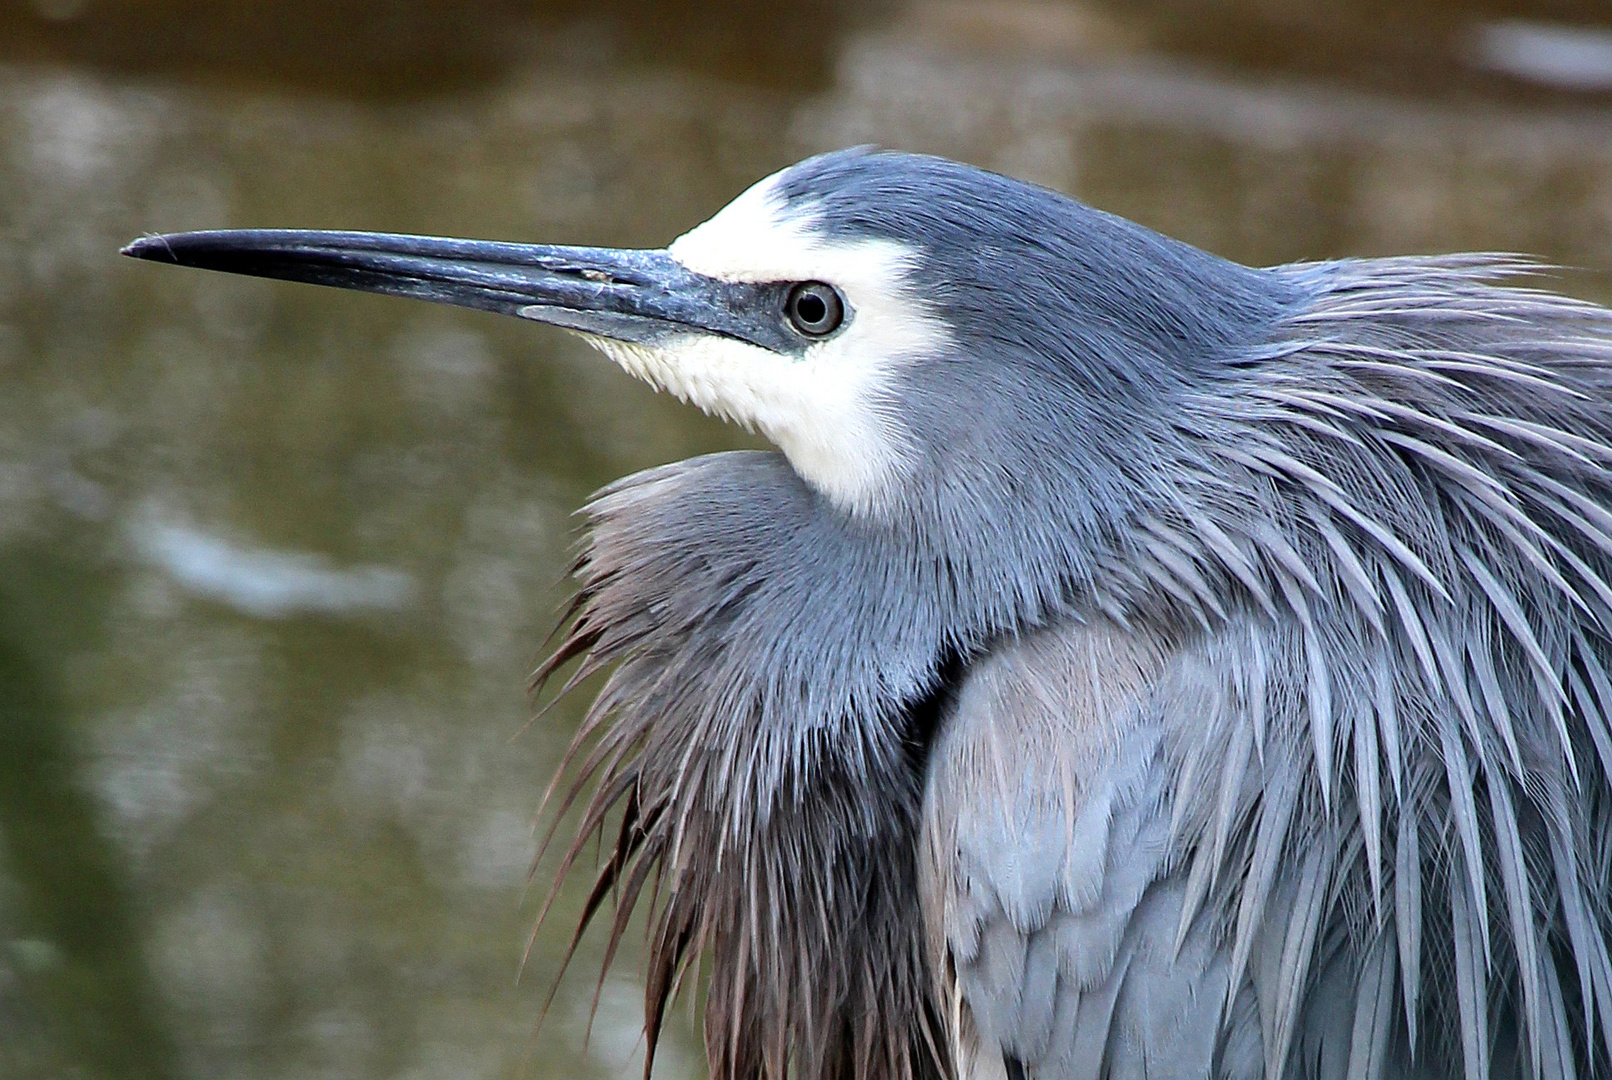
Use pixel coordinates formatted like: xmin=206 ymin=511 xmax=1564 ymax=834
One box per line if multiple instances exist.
xmin=588 ymin=176 xmax=949 ymax=513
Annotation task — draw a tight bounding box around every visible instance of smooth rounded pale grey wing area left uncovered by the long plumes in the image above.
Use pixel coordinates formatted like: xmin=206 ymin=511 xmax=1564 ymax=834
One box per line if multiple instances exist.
xmin=925 ymin=630 xmax=1230 ymax=1080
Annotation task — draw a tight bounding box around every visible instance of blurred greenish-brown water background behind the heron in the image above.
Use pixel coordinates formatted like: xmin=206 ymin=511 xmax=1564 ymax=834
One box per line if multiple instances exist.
xmin=0 ymin=0 xmax=1612 ymax=1080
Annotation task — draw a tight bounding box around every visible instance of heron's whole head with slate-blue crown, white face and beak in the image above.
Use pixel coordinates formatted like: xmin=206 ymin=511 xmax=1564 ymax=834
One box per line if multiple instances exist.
xmin=126 ymin=150 xmax=1282 ymax=516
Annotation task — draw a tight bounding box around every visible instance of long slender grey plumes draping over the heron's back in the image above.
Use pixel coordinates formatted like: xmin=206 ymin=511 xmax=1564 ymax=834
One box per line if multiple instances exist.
xmin=1145 ymin=256 xmax=1612 ymax=1080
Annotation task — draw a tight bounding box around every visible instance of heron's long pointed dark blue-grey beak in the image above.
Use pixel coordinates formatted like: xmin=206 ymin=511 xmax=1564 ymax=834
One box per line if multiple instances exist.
xmin=123 ymin=229 xmax=754 ymax=342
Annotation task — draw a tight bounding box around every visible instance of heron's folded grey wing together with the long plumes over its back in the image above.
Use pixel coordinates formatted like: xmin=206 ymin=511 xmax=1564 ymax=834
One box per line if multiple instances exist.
xmin=922 ymin=256 xmax=1612 ymax=1080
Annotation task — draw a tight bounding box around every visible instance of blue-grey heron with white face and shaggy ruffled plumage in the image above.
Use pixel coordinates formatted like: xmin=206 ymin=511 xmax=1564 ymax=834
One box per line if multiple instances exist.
xmin=126 ymin=148 xmax=1612 ymax=1080
